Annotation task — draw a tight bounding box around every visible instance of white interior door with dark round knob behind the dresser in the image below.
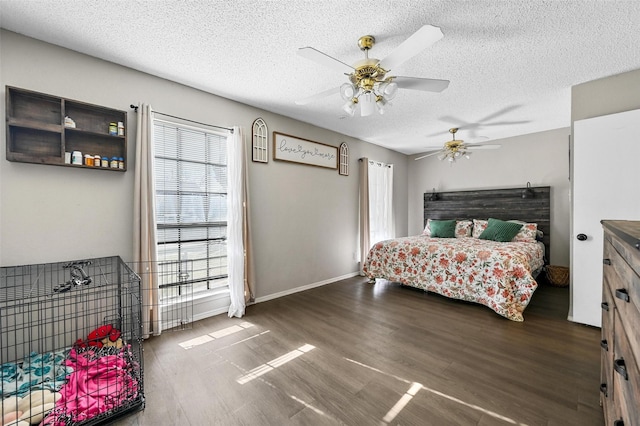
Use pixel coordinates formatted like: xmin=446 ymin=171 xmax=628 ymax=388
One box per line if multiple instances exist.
xmin=570 ymin=110 xmax=640 ymax=327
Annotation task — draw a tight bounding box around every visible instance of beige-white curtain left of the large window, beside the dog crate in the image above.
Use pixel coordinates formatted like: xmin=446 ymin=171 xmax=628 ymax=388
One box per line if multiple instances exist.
xmin=133 ymin=104 xmax=162 ymax=339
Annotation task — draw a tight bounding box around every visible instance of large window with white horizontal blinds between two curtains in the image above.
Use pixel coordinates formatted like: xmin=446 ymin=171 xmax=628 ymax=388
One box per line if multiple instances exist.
xmin=153 ymin=119 xmax=228 ymax=300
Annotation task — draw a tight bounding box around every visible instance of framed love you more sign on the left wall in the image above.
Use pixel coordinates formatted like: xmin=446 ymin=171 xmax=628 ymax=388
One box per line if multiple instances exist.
xmin=273 ymin=132 xmax=338 ymax=170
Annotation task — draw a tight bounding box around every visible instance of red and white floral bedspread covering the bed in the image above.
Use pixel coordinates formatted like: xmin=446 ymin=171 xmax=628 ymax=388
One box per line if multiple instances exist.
xmin=363 ymin=236 xmax=544 ymax=321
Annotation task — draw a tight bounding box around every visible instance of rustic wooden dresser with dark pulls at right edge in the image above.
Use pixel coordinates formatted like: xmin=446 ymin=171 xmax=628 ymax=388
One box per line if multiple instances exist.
xmin=600 ymin=220 xmax=640 ymax=426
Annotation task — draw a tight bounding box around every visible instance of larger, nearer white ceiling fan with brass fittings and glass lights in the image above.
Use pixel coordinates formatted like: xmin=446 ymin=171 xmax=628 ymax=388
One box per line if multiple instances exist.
xmin=296 ymin=25 xmax=449 ymax=116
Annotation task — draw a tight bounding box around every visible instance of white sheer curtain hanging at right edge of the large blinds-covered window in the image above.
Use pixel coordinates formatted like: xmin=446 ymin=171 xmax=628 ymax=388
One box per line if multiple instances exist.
xmin=227 ymin=126 xmax=246 ymax=318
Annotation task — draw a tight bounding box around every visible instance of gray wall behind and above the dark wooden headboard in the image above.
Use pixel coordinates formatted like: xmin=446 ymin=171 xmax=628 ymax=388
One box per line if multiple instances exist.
xmin=409 ymin=128 xmax=569 ymax=266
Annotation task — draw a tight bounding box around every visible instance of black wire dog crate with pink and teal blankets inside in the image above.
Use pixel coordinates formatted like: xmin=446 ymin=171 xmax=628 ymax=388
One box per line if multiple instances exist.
xmin=0 ymin=256 xmax=144 ymax=426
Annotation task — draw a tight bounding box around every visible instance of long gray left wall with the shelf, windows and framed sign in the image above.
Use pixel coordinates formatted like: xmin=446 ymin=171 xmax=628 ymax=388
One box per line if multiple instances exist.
xmin=0 ymin=30 xmax=408 ymax=298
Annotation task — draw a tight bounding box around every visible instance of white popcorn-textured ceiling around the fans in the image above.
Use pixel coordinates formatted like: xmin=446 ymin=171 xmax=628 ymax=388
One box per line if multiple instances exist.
xmin=0 ymin=0 xmax=640 ymax=154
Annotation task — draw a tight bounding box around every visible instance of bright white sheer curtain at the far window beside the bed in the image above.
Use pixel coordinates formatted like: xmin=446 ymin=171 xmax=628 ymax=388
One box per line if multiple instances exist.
xmin=367 ymin=160 xmax=396 ymax=247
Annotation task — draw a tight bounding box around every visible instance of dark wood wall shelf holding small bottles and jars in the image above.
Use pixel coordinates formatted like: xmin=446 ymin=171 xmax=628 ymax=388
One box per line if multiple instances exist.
xmin=6 ymin=86 xmax=128 ymax=172
